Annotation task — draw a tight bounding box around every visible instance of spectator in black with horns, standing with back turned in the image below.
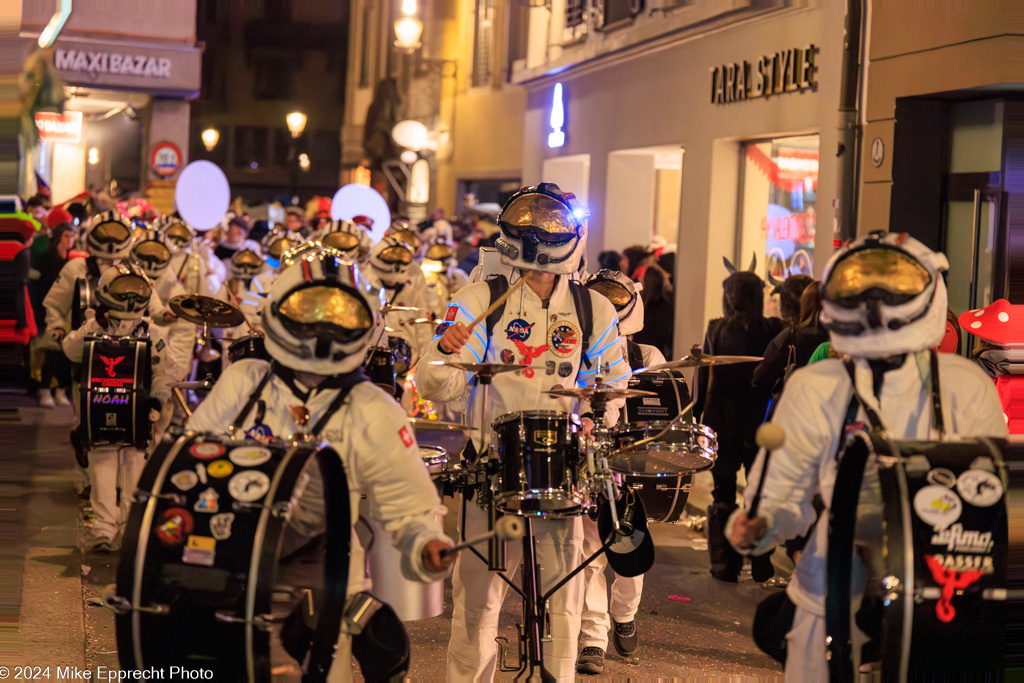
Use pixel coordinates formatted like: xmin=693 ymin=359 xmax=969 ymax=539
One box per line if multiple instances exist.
xmin=694 ymin=271 xmax=782 ymax=583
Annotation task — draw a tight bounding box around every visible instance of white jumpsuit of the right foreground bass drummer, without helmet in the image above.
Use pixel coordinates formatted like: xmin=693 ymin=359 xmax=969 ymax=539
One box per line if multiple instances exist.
xmin=726 ymin=352 xmax=1008 ymax=681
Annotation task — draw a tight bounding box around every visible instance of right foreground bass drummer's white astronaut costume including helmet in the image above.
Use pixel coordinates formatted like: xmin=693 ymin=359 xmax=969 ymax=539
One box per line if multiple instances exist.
xmin=726 ymin=232 xmax=1008 ymax=681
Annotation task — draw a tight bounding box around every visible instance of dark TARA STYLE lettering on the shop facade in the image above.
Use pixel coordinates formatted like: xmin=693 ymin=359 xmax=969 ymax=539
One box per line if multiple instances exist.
xmin=711 ymin=45 xmax=818 ymax=104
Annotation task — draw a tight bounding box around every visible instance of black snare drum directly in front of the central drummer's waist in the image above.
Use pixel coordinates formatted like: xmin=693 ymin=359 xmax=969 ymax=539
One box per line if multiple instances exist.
xmin=494 ymin=411 xmax=587 ymax=517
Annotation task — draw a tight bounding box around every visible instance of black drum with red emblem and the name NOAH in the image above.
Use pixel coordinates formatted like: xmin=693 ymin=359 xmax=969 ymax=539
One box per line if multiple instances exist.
xmin=80 ymin=337 xmax=151 ymax=449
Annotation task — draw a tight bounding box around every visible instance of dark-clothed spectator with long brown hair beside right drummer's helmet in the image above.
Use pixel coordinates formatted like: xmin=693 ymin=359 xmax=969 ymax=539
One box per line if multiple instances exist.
xmin=754 ymin=275 xmax=828 ymax=395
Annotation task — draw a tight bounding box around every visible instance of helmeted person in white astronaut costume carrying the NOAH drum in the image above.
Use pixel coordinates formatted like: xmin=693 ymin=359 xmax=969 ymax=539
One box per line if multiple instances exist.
xmin=62 ymin=264 xmax=171 ymax=552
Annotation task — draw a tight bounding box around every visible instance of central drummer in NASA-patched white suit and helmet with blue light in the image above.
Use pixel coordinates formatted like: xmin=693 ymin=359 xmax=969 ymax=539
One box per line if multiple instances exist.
xmin=416 ymin=183 xmax=630 ymax=681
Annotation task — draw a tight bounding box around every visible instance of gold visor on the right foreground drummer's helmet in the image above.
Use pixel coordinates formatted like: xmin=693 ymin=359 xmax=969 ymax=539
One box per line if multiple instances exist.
xmin=825 ymin=249 xmax=932 ymax=301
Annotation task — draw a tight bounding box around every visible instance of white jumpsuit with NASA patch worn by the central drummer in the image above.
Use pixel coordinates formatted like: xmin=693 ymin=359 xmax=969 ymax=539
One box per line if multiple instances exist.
xmin=416 ymin=272 xmax=631 ymax=681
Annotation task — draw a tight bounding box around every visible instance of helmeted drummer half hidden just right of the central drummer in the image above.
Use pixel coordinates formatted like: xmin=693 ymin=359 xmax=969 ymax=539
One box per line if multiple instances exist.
xmin=577 ymin=269 xmax=665 ymax=674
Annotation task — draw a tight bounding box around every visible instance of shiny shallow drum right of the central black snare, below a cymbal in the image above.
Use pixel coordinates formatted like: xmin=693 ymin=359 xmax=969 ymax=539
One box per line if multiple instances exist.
xmin=608 ymin=422 xmax=718 ymax=479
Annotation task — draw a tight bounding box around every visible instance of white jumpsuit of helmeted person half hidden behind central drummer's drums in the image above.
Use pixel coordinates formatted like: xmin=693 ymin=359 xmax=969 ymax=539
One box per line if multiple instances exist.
xmin=580 ymin=344 xmax=665 ymax=650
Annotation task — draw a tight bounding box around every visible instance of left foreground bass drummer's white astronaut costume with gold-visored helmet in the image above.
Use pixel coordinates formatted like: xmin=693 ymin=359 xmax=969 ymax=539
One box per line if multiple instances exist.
xmin=187 ymin=248 xmax=450 ymax=681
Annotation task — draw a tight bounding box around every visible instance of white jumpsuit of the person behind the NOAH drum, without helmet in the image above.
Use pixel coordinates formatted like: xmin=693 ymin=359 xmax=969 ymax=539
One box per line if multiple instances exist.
xmin=62 ymin=317 xmax=171 ymax=540
